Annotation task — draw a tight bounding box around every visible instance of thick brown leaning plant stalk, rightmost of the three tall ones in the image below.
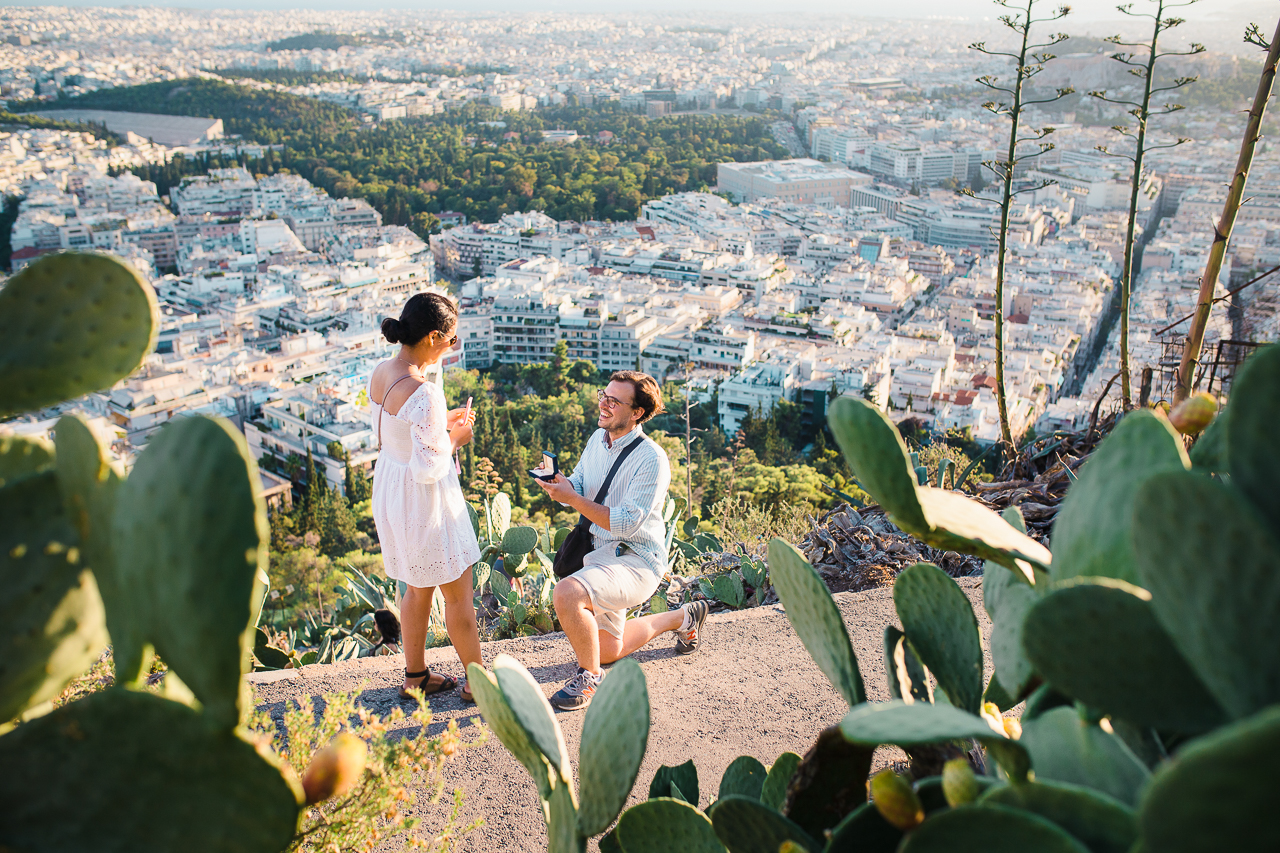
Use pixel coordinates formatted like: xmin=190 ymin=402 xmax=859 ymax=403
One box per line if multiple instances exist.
xmin=1174 ymin=22 xmax=1280 ymax=403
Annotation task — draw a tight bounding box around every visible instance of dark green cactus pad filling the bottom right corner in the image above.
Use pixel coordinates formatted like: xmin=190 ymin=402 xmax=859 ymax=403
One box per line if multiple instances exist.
xmin=1138 ymin=707 xmax=1280 ymax=853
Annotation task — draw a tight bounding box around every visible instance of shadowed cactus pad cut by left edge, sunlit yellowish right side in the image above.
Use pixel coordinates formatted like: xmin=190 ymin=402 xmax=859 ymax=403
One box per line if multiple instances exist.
xmin=0 ymin=471 xmax=106 ymax=722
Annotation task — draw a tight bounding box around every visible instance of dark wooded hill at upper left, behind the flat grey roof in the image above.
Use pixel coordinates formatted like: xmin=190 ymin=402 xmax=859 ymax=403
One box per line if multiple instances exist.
xmin=9 ymin=78 xmax=355 ymax=143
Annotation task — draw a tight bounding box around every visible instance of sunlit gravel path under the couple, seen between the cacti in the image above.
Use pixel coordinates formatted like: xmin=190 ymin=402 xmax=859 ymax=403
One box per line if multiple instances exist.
xmin=248 ymin=578 xmax=991 ymax=853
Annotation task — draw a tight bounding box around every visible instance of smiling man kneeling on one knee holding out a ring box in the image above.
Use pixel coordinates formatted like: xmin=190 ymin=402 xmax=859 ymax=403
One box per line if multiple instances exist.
xmin=539 ymin=370 xmax=707 ymax=711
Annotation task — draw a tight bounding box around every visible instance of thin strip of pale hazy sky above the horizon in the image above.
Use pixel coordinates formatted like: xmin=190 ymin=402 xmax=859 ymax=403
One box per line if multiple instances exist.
xmin=6 ymin=0 xmax=1276 ymax=23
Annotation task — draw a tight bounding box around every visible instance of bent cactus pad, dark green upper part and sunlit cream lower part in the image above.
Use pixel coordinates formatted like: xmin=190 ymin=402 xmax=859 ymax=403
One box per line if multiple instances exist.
xmin=824 ymin=397 xmax=1052 ymax=580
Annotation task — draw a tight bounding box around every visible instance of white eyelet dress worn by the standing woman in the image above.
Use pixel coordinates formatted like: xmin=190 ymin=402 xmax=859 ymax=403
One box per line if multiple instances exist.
xmin=370 ymin=382 xmax=480 ymax=587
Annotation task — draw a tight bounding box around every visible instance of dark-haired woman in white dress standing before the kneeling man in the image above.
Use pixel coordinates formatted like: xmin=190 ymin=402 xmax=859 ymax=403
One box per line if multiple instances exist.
xmin=369 ymin=293 xmax=483 ymax=702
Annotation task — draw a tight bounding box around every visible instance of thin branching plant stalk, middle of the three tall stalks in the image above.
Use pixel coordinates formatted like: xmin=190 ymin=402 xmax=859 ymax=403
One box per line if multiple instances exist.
xmin=1089 ymin=0 xmax=1204 ymax=409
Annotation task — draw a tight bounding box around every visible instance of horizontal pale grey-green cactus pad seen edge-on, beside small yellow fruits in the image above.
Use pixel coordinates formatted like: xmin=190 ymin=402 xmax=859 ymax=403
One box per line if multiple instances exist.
xmin=840 ymin=701 xmax=1028 ymax=779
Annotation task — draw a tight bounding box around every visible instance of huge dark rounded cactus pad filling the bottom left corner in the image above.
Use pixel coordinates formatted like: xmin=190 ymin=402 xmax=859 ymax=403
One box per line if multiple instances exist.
xmin=0 ymin=689 xmax=301 ymax=853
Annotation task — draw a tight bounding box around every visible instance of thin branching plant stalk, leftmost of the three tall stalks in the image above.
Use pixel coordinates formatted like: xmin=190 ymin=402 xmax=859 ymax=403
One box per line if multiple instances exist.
xmin=969 ymin=0 xmax=1075 ymax=448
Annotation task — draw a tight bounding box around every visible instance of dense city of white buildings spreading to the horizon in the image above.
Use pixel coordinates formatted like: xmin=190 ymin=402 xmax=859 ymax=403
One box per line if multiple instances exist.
xmin=0 ymin=8 xmax=1280 ymax=488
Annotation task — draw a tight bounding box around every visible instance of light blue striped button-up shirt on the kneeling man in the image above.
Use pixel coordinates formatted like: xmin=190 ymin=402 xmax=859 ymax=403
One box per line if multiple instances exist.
xmin=568 ymin=425 xmax=671 ymax=576
